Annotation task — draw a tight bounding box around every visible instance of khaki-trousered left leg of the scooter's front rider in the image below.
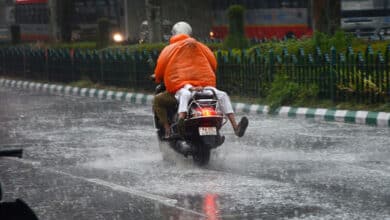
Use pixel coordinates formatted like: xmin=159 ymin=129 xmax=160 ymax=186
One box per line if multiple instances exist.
xmin=153 ymin=91 xmax=177 ymax=128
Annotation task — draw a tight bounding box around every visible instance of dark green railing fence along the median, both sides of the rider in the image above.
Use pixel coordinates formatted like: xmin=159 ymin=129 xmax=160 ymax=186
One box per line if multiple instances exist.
xmin=0 ymin=46 xmax=390 ymax=103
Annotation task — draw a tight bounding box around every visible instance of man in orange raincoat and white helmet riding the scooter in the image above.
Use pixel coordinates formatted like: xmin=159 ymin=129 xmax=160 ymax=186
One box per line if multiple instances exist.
xmin=153 ymin=21 xmax=248 ymax=139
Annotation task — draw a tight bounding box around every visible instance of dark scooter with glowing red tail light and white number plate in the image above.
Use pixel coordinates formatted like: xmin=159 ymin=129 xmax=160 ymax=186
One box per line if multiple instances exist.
xmin=154 ymin=84 xmax=227 ymax=166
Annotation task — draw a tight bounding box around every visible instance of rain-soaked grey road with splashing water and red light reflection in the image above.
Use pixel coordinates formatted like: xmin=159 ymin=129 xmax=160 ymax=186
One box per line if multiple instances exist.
xmin=0 ymin=87 xmax=390 ymax=220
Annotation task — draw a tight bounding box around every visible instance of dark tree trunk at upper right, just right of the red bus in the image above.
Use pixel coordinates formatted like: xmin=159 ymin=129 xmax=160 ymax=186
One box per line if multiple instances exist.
xmin=310 ymin=0 xmax=341 ymax=34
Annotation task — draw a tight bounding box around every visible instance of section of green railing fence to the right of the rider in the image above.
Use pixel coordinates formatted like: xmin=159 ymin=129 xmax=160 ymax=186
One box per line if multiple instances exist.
xmin=216 ymin=46 xmax=390 ymax=103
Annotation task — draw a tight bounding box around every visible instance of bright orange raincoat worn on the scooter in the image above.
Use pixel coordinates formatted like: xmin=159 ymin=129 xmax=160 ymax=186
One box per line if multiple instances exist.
xmin=154 ymin=34 xmax=217 ymax=94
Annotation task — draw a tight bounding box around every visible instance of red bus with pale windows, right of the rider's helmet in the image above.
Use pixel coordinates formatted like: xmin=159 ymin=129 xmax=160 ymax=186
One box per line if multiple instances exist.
xmin=212 ymin=0 xmax=312 ymax=39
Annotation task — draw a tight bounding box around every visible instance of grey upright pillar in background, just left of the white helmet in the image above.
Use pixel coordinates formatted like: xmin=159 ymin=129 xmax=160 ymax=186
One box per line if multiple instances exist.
xmin=145 ymin=0 xmax=162 ymax=43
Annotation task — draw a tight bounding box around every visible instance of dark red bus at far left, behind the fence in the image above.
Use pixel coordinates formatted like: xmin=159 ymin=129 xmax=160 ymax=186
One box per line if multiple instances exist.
xmin=15 ymin=0 xmax=50 ymax=41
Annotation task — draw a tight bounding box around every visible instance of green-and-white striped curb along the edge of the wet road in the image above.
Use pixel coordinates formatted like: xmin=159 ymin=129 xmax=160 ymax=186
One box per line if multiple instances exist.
xmin=0 ymin=78 xmax=390 ymax=127
